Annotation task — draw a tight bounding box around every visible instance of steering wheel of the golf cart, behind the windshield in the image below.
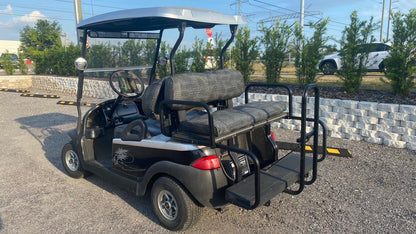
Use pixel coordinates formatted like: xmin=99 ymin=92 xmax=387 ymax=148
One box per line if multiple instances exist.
xmin=110 ymin=70 xmax=144 ymax=98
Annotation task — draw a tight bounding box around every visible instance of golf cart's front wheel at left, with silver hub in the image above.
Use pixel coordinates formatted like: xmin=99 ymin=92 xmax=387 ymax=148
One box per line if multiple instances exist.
xmin=61 ymin=142 xmax=85 ymax=179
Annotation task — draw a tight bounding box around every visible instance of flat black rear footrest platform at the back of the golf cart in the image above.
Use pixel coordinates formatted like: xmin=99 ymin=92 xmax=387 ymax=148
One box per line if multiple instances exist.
xmin=225 ymin=154 xmax=313 ymax=209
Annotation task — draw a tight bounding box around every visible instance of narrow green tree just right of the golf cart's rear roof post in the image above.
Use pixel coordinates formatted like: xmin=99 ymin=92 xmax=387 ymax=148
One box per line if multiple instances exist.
xmin=231 ymin=26 xmax=259 ymax=83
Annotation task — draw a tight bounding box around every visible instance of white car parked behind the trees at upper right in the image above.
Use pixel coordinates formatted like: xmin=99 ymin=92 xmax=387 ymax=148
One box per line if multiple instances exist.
xmin=318 ymin=43 xmax=390 ymax=75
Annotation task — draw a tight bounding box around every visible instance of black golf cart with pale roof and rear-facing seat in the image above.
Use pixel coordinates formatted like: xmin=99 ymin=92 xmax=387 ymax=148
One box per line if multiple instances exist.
xmin=62 ymin=7 xmax=324 ymax=230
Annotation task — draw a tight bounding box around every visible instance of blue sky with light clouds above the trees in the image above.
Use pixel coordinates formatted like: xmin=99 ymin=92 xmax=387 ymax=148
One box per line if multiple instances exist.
xmin=0 ymin=0 xmax=416 ymax=48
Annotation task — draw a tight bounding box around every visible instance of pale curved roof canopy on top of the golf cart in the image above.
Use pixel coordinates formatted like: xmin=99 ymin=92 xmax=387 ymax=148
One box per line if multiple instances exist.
xmin=78 ymin=7 xmax=246 ymax=32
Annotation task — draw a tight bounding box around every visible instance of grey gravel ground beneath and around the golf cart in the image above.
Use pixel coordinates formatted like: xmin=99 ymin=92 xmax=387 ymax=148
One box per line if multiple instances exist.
xmin=0 ymin=92 xmax=416 ymax=233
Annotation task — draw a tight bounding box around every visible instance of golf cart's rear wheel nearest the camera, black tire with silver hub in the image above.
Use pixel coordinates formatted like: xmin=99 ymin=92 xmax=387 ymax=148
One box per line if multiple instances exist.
xmin=151 ymin=177 xmax=202 ymax=231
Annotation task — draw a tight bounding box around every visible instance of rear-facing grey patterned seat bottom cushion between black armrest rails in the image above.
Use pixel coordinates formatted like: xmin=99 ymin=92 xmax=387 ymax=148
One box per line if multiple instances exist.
xmin=179 ymin=102 xmax=286 ymax=137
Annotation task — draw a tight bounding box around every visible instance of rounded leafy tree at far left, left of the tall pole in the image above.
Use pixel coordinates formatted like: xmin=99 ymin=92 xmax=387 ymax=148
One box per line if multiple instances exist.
xmin=20 ymin=19 xmax=62 ymax=60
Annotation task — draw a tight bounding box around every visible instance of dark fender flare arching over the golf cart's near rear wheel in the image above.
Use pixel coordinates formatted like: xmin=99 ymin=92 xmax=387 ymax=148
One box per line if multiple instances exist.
xmin=141 ymin=161 xmax=228 ymax=208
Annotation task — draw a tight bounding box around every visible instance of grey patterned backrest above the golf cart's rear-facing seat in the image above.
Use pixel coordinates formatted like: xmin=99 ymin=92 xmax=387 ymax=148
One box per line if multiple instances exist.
xmin=164 ymin=69 xmax=245 ymax=110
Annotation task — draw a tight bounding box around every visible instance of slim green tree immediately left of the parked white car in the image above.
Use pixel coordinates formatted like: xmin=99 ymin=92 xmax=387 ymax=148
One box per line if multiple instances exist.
xmin=294 ymin=19 xmax=328 ymax=86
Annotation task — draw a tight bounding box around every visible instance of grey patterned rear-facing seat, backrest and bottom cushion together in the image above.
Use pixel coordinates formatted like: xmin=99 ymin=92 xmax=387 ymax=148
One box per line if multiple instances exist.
xmin=164 ymin=69 xmax=286 ymax=142
